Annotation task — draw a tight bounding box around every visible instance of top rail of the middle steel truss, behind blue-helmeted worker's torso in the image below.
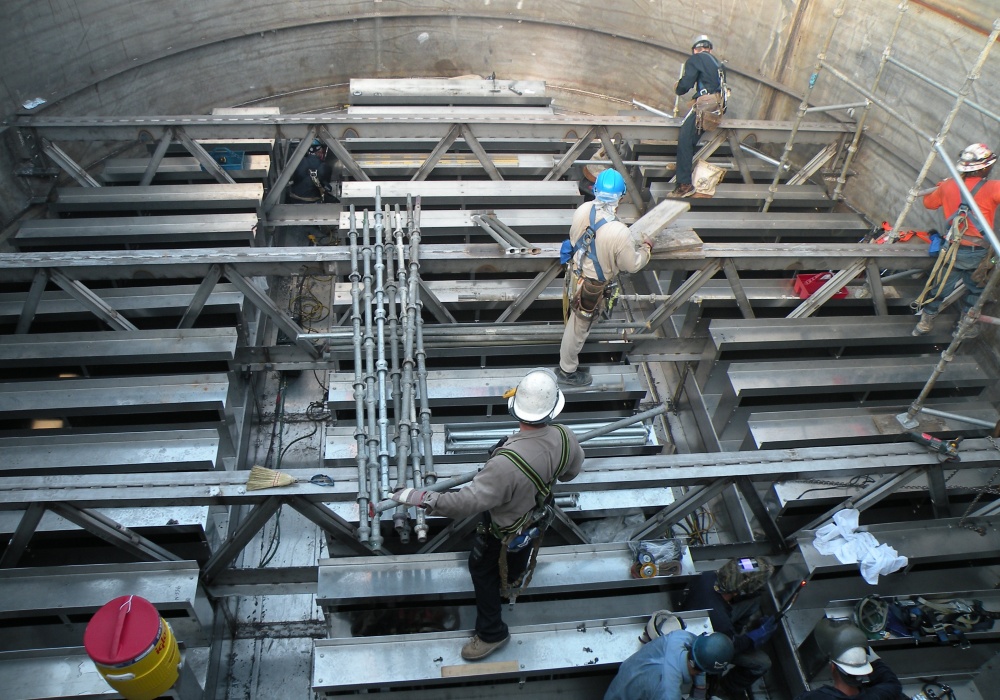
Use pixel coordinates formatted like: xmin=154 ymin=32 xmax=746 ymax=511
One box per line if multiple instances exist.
xmin=0 ymin=243 xmax=934 ymax=282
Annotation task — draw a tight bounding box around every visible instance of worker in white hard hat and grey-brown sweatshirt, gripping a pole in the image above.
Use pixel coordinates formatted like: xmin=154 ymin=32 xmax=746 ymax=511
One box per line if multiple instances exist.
xmin=391 ymin=369 xmax=583 ymax=661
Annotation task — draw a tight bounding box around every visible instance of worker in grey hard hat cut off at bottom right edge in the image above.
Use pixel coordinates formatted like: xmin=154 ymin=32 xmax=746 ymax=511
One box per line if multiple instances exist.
xmin=795 ymin=618 xmax=907 ymax=700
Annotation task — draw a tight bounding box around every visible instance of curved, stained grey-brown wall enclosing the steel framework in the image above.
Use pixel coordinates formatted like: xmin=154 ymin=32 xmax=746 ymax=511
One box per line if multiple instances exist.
xmin=0 ymin=0 xmax=1000 ymax=238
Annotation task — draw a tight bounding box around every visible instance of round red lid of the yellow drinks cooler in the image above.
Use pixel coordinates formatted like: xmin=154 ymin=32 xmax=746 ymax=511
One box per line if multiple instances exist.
xmin=83 ymin=595 xmax=160 ymax=666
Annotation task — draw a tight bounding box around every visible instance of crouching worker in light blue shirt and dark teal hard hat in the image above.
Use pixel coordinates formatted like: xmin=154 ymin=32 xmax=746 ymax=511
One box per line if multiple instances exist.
xmin=604 ymin=630 xmax=733 ymax=700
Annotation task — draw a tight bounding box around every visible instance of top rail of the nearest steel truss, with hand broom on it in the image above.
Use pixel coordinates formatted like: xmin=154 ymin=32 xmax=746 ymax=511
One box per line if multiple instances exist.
xmin=0 ymin=439 xmax=997 ymax=510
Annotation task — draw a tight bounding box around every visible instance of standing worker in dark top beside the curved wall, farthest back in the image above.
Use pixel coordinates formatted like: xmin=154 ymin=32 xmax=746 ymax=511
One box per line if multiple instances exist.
xmin=668 ymin=34 xmax=728 ymax=197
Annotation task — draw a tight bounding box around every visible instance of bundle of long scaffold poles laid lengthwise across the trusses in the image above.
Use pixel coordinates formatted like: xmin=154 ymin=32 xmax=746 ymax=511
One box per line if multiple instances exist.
xmin=348 ymin=189 xmax=434 ymax=549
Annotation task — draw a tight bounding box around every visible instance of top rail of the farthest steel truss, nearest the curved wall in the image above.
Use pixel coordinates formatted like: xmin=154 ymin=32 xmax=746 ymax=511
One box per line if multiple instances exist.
xmin=17 ymin=114 xmax=853 ymax=145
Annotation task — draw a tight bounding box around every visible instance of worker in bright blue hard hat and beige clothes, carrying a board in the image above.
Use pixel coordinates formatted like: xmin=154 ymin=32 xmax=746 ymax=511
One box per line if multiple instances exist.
xmin=556 ymin=168 xmax=653 ymax=387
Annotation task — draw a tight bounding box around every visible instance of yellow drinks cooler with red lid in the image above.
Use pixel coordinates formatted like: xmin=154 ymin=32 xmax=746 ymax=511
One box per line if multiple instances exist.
xmin=83 ymin=596 xmax=181 ymax=700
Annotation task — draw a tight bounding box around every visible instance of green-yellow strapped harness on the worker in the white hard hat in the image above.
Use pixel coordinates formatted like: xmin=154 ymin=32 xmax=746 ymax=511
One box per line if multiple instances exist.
xmin=490 ymin=424 xmax=570 ymax=605
